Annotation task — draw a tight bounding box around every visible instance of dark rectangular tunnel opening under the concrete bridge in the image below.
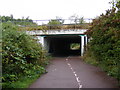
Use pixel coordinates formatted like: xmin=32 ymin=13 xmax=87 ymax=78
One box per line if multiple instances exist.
xmin=44 ymin=35 xmax=81 ymax=56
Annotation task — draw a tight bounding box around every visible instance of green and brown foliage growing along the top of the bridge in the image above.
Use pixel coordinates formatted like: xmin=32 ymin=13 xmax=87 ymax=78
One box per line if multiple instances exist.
xmin=0 ymin=15 xmax=89 ymax=32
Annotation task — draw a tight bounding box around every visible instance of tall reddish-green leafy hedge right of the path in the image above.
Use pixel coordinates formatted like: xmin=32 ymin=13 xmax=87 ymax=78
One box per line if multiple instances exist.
xmin=87 ymin=1 xmax=120 ymax=80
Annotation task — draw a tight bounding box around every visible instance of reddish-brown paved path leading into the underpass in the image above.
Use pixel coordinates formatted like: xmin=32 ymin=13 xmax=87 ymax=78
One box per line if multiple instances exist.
xmin=30 ymin=56 xmax=117 ymax=88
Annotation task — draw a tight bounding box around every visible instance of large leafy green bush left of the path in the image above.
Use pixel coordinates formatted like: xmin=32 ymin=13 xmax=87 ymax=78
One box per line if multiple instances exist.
xmin=2 ymin=22 xmax=47 ymax=82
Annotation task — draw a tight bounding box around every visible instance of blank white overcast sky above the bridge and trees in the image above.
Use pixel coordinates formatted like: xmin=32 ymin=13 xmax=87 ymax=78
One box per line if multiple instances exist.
xmin=0 ymin=0 xmax=112 ymax=20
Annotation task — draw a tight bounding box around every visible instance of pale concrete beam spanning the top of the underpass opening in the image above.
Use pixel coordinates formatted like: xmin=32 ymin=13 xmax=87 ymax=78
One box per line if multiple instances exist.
xmin=26 ymin=29 xmax=87 ymax=35
